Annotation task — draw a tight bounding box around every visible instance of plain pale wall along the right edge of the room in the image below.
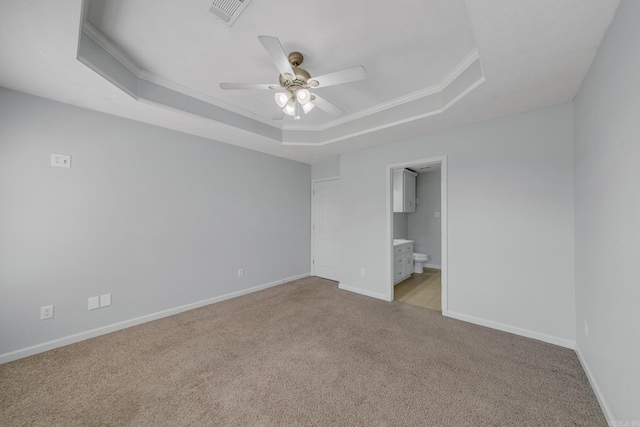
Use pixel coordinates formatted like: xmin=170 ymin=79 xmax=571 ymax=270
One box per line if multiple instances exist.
xmin=575 ymin=0 xmax=640 ymax=425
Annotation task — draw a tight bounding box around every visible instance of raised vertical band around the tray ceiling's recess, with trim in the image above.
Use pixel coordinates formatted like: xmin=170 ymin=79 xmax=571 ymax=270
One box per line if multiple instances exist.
xmin=78 ymin=20 xmax=485 ymax=146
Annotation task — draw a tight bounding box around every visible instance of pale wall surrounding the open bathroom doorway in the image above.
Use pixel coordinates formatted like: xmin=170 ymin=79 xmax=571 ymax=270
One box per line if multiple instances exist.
xmin=340 ymin=105 xmax=575 ymax=347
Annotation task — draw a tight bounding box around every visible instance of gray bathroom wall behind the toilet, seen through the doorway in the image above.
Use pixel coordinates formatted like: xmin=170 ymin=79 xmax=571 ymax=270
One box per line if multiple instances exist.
xmin=407 ymin=172 xmax=442 ymax=267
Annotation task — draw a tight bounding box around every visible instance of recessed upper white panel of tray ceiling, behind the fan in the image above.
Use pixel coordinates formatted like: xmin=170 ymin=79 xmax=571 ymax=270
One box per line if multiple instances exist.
xmin=87 ymin=0 xmax=475 ymax=126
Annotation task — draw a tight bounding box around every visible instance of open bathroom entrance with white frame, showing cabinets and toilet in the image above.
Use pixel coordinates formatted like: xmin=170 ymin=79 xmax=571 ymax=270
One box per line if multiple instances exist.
xmin=389 ymin=158 xmax=447 ymax=314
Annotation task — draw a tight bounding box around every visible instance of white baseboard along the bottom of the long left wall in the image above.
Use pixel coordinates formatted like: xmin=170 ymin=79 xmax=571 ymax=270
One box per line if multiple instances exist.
xmin=0 ymin=273 xmax=310 ymax=364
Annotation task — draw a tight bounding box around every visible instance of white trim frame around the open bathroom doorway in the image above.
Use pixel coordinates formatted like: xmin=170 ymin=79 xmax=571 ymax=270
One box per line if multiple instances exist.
xmin=386 ymin=156 xmax=449 ymax=316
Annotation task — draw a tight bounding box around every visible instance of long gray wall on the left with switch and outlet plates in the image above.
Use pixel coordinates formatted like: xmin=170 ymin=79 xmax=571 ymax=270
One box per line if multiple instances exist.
xmin=0 ymin=89 xmax=311 ymax=355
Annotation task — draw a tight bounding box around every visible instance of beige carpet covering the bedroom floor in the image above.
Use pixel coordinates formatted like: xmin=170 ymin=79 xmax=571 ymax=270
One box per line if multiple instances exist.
xmin=0 ymin=278 xmax=606 ymax=426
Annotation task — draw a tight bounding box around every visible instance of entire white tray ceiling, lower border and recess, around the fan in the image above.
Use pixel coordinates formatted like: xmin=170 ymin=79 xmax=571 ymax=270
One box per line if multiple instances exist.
xmin=0 ymin=0 xmax=620 ymax=164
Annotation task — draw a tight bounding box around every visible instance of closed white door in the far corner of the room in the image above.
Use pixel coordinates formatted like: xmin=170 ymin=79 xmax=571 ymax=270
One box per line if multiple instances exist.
xmin=312 ymin=179 xmax=340 ymax=280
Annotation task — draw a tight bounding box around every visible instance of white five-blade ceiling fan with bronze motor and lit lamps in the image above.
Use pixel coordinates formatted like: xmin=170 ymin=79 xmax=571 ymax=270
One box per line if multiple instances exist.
xmin=220 ymin=36 xmax=367 ymax=120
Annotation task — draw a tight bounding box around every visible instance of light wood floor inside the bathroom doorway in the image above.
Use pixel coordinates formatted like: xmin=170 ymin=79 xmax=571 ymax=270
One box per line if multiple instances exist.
xmin=393 ymin=268 xmax=442 ymax=311
